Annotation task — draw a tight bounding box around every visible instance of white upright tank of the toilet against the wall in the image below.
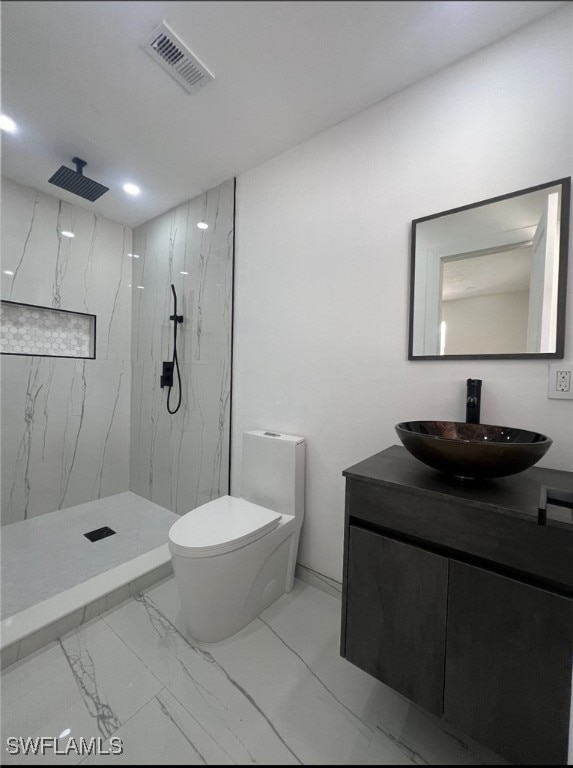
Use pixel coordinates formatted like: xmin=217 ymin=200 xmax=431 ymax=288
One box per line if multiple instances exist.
xmin=241 ymin=429 xmax=305 ymax=523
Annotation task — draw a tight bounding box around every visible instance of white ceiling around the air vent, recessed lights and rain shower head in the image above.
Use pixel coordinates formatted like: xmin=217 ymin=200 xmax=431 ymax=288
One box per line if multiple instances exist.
xmin=1 ymin=0 xmax=565 ymax=227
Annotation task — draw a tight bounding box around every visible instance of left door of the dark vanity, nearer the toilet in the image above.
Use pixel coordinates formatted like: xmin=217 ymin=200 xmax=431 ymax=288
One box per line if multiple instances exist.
xmin=346 ymin=525 xmax=448 ymax=715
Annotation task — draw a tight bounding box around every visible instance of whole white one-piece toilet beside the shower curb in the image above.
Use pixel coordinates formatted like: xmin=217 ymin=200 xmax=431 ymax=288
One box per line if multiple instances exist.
xmin=169 ymin=430 xmax=305 ymax=643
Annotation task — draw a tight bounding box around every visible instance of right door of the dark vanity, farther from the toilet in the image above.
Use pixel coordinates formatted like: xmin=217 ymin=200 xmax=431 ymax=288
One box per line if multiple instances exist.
xmin=444 ymin=560 xmax=573 ymax=765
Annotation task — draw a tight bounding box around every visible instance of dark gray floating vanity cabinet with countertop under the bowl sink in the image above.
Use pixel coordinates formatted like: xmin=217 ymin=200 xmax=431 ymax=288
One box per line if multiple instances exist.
xmin=341 ymin=446 xmax=573 ymax=765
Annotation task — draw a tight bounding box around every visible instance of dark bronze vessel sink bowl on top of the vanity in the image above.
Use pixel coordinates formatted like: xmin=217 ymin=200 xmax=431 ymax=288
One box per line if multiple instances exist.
xmin=395 ymin=421 xmax=553 ymax=479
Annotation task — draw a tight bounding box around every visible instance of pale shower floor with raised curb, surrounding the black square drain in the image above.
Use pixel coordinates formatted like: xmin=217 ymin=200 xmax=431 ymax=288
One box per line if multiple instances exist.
xmin=0 ymin=491 xmax=179 ymax=667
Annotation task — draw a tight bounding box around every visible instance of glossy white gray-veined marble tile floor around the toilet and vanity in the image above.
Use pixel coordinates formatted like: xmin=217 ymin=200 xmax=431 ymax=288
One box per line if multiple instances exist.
xmin=2 ymin=578 xmax=504 ymax=765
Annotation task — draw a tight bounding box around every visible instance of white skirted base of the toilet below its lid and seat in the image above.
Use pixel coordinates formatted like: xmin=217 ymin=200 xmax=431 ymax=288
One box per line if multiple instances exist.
xmin=171 ymin=515 xmax=301 ymax=643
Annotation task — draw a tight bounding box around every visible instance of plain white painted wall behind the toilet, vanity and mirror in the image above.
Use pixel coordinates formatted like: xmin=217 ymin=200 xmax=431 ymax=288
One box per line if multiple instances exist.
xmin=231 ymin=7 xmax=573 ymax=580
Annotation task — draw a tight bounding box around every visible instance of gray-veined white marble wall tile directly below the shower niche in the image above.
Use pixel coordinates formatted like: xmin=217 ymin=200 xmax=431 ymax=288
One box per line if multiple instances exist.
xmin=2 ymin=356 xmax=131 ymax=523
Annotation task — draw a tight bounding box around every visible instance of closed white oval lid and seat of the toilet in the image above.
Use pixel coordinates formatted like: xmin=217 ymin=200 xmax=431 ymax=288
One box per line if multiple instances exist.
xmin=169 ymin=496 xmax=281 ymax=557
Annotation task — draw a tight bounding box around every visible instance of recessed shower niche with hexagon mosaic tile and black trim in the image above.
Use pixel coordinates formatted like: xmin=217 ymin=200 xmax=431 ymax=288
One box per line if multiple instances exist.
xmin=0 ymin=301 xmax=96 ymax=360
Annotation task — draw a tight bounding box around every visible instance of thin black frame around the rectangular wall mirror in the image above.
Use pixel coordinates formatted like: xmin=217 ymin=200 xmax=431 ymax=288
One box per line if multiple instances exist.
xmin=408 ymin=176 xmax=571 ymax=360
